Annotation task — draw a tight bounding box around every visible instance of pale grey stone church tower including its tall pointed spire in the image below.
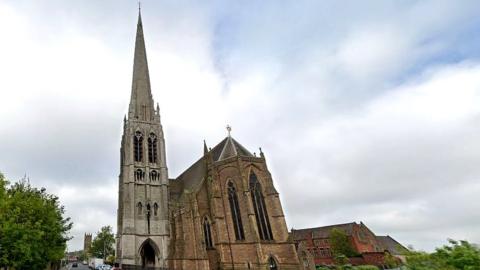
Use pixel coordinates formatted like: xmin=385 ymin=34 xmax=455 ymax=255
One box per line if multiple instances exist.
xmin=116 ymin=10 xmax=169 ymax=270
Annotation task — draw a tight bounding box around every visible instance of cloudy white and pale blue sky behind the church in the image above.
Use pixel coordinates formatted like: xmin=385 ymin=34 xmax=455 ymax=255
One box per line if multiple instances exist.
xmin=0 ymin=0 xmax=480 ymax=253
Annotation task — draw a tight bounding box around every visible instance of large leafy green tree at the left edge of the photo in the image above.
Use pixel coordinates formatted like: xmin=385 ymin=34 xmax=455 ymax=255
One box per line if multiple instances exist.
xmin=0 ymin=174 xmax=72 ymax=270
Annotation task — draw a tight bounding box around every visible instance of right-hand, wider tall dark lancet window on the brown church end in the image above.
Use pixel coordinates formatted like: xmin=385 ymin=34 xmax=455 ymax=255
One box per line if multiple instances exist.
xmin=250 ymin=172 xmax=273 ymax=240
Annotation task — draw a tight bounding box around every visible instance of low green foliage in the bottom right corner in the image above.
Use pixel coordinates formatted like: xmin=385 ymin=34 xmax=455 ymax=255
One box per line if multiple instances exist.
xmin=407 ymin=239 xmax=480 ymax=270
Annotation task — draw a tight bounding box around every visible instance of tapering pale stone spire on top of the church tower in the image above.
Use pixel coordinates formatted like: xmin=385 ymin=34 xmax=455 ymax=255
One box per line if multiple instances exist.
xmin=128 ymin=9 xmax=155 ymax=121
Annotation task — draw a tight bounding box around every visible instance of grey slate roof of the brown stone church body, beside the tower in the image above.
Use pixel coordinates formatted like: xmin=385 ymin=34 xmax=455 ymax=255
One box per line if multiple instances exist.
xmin=169 ymin=136 xmax=253 ymax=199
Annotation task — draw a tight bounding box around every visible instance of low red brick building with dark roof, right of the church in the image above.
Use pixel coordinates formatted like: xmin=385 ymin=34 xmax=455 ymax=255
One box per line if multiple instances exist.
xmin=291 ymin=222 xmax=407 ymax=269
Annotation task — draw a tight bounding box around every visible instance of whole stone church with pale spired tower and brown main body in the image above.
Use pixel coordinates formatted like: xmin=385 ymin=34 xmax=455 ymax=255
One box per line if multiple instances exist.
xmin=116 ymin=11 xmax=299 ymax=270
